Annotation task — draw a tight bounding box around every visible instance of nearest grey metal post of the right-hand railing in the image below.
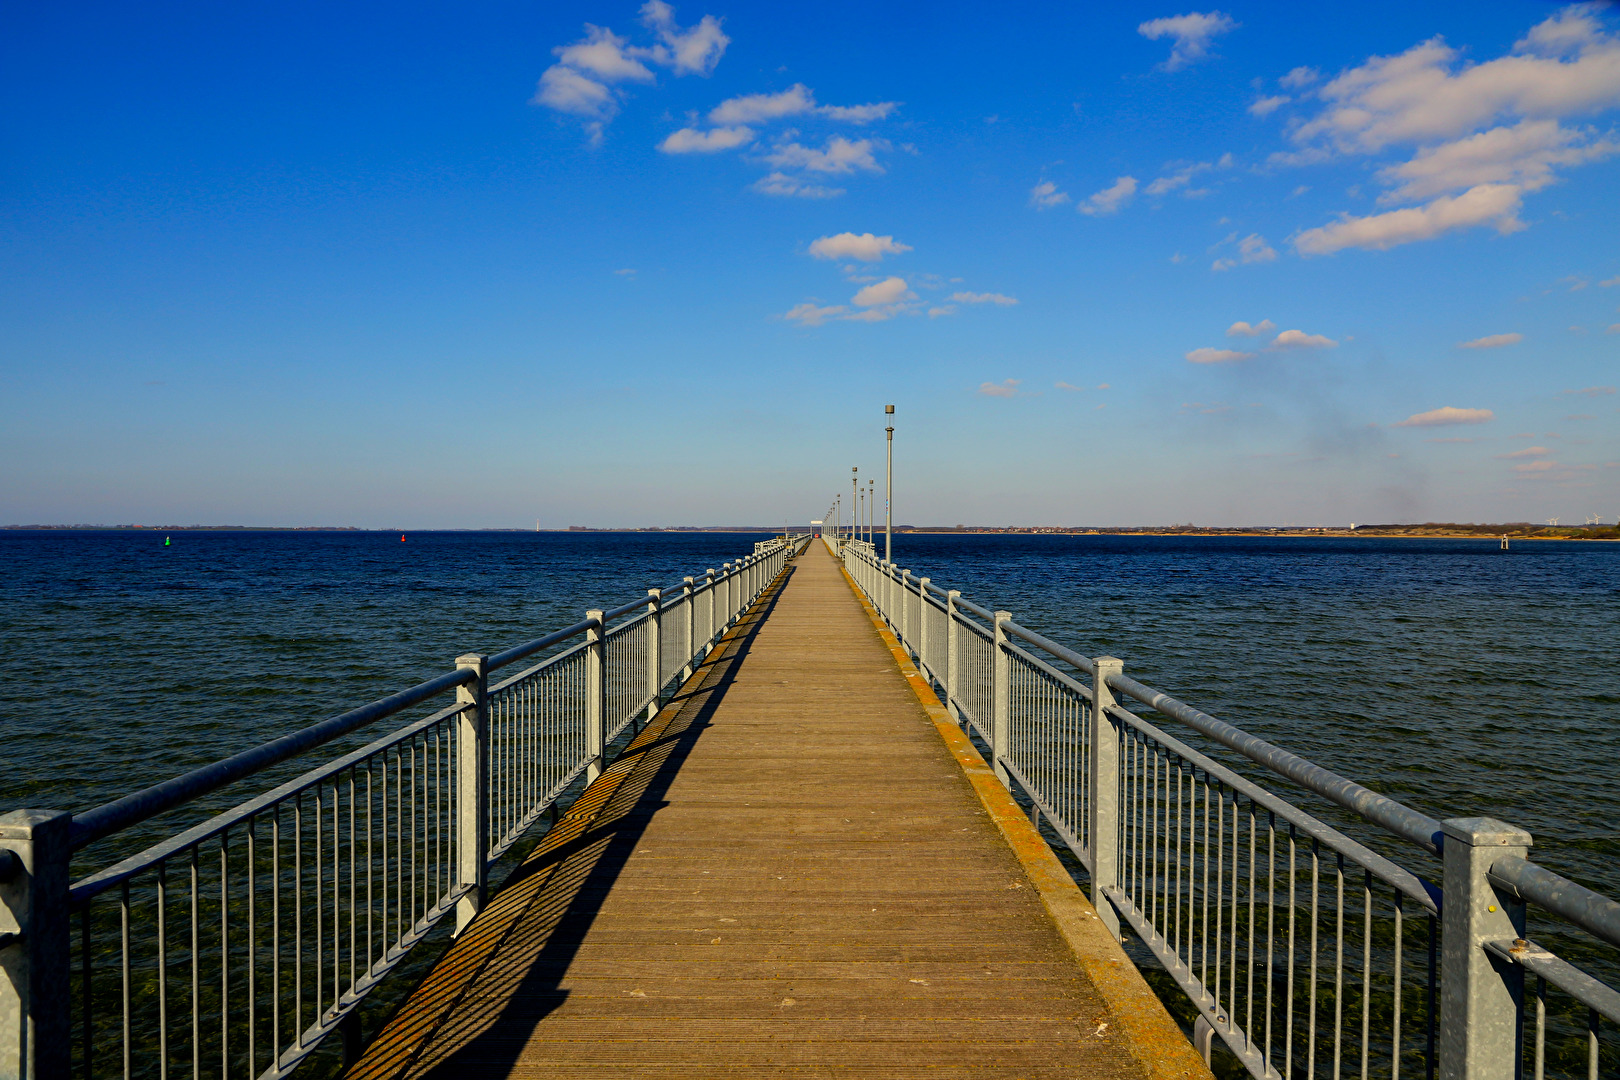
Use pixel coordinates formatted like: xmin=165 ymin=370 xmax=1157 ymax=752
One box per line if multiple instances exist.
xmin=1439 ymin=818 xmax=1531 ymax=1080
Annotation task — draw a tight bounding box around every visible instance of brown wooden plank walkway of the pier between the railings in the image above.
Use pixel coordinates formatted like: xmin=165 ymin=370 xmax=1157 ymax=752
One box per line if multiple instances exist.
xmin=348 ymin=542 xmax=1209 ymax=1080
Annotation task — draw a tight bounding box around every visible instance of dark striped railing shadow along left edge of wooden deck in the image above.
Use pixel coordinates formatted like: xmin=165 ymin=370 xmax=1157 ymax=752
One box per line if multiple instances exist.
xmin=347 ymin=563 xmax=795 ymax=1080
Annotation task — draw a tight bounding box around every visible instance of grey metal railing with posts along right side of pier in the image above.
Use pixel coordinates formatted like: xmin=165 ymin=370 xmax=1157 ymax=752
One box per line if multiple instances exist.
xmin=828 ymin=539 xmax=1620 ymax=1080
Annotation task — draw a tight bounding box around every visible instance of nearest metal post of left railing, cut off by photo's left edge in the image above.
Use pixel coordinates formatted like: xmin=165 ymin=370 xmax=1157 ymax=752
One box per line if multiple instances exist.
xmin=0 ymin=810 xmax=73 ymax=1080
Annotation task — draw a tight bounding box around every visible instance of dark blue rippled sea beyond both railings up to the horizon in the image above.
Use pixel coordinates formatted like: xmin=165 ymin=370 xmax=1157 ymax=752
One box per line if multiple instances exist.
xmin=0 ymin=531 xmax=1620 ymax=895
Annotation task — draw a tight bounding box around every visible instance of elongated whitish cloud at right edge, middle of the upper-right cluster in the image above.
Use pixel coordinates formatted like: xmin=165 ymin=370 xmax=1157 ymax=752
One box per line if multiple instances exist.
xmin=1379 ymin=120 xmax=1620 ymax=202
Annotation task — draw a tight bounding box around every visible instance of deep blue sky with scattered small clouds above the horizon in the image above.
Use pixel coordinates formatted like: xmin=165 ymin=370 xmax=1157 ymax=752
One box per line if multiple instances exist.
xmin=0 ymin=0 xmax=1620 ymax=528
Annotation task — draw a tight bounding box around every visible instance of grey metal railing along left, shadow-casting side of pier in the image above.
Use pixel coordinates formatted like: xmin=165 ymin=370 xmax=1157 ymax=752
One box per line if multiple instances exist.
xmin=0 ymin=536 xmax=808 ymax=1080
